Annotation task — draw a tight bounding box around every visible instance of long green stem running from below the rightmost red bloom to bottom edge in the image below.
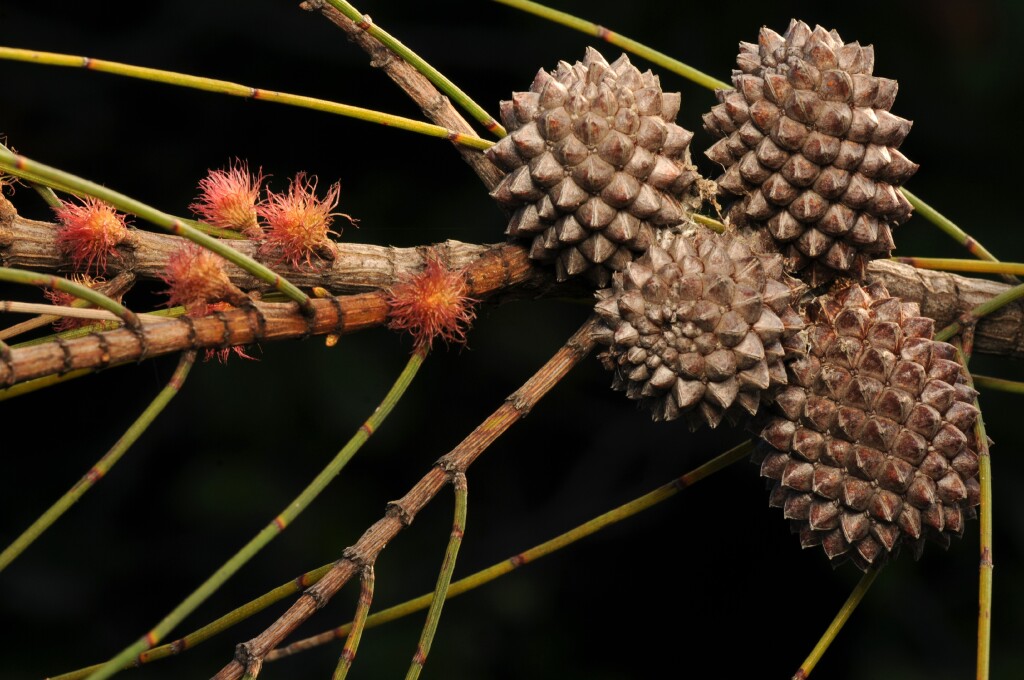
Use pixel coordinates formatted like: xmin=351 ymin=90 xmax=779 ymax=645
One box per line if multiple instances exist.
xmin=81 ymin=348 xmax=428 ymax=680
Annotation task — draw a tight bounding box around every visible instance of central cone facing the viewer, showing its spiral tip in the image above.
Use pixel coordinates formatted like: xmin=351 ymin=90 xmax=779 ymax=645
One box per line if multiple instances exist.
xmin=595 ymin=227 xmax=805 ymax=429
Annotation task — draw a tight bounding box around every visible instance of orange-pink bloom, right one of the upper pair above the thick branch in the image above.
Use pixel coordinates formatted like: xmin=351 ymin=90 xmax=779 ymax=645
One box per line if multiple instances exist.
xmin=256 ymin=172 xmax=354 ymax=267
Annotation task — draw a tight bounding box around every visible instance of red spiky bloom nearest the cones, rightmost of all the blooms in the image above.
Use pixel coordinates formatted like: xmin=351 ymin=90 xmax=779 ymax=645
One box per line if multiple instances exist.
xmin=388 ymin=253 xmax=476 ymax=349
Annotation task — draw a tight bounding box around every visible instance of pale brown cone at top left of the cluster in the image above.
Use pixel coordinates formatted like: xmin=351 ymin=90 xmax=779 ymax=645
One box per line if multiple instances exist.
xmin=486 ymin=48 xmax=697 ymax=288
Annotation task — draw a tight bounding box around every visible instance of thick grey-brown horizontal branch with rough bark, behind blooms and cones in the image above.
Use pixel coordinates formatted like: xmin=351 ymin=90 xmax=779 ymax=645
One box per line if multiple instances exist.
xmin=0 ymin=197 xmax=1024 ymax=356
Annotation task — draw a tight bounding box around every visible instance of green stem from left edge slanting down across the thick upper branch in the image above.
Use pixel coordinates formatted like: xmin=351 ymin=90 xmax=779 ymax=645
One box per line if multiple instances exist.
xmin=0 ymin=150 xmax=312 ymax=314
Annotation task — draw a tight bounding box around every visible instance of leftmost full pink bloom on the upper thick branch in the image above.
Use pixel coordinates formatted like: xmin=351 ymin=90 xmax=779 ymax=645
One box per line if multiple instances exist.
xmin=53 ymin=196 xmax=128 ymax=270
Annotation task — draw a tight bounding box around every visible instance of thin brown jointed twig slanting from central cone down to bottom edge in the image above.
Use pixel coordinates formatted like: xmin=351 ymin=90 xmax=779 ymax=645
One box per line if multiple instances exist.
xmin=214 ymin=318 xmax=594 ymax=680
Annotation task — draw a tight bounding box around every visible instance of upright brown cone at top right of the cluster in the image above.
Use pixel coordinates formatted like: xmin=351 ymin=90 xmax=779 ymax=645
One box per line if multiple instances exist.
xmin=703 ymin=19 xmax=918 ymax=286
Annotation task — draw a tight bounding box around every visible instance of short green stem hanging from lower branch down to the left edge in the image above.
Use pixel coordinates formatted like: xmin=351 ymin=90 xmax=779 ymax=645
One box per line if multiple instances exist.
xmin=0 ymin=351 xmax=196 ymax=571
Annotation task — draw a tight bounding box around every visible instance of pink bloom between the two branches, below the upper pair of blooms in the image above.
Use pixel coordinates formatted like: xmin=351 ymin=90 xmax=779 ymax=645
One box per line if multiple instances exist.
xmin=160 ymin=243 xmax=247 ymax=316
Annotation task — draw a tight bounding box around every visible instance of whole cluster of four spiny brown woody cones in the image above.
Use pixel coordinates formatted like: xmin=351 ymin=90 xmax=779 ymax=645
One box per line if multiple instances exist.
xmin=488 ymin=20 xmax=978 ymax=569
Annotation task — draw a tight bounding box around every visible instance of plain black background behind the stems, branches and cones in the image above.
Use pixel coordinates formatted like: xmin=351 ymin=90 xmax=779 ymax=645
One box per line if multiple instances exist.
xmin=0 ymin=0 xmax=1024 ymax=680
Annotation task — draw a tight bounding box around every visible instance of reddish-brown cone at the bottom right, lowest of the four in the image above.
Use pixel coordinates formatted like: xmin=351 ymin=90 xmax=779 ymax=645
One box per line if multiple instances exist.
xmin=761 ymin=284 xmax=979 ymax=570
